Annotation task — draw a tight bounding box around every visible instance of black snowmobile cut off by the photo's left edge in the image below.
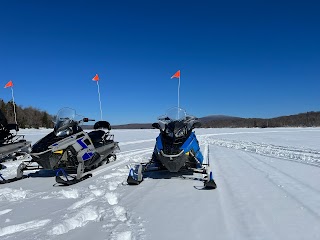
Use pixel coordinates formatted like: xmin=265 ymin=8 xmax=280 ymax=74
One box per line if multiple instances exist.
xmin=0 ymin=110 xmax=31 ymax=165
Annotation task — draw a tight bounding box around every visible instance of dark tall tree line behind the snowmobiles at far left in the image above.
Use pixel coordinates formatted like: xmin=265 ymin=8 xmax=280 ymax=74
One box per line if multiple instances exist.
xmin=0 ymin=99 xmax=54 ymax=128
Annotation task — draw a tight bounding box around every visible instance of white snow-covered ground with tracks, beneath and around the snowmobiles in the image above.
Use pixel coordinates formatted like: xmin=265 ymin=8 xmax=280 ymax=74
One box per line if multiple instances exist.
xmin=0 ymin=128 xmax=320 ymax=240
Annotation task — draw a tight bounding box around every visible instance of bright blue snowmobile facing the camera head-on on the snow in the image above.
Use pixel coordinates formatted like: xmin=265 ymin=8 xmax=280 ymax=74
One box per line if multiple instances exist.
xmin=127 ymin=107 xmax=217 ymax=189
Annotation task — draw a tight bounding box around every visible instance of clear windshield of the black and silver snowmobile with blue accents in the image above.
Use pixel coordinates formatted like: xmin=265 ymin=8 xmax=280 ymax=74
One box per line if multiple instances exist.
xmin=54 ymin=108 xmax=76 ymax=137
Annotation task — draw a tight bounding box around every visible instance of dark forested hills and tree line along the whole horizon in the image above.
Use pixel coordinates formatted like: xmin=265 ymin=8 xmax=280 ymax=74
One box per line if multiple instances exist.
xmin=0 ymin=99 xmax=320 ymax=129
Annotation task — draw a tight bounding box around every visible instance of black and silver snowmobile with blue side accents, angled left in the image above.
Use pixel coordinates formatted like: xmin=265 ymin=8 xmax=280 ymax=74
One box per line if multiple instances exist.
xmin=0 ymin=108 xmax=119 ymax=185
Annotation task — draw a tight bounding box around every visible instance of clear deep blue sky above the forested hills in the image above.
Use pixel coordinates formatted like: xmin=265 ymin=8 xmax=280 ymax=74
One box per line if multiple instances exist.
xmin=0 ymin=0 xmax=320 ymax=124
